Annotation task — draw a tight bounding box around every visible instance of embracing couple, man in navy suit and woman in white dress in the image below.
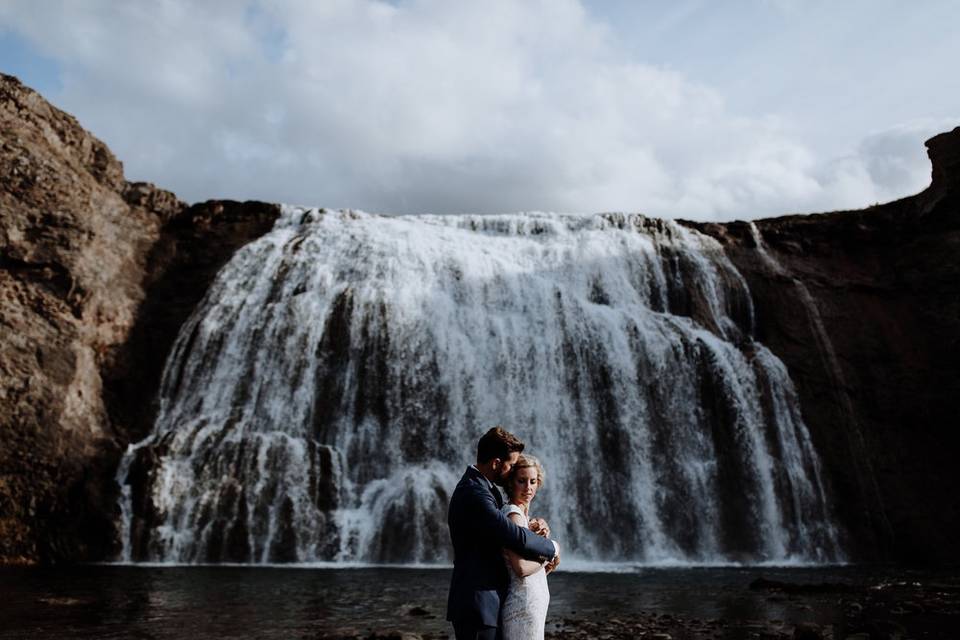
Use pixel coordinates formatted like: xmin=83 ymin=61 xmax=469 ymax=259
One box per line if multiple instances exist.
xmin=447 ymin=427 xmax=560 ymax=640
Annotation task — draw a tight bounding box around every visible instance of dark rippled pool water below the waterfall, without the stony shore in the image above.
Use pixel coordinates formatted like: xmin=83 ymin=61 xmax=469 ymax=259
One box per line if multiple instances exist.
xmin=0 ymin=565 xmax=960 ymax=640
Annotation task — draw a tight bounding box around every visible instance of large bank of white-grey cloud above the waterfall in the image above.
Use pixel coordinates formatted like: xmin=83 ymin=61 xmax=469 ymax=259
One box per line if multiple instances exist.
xmin=0 ymin=0 xmax=950 ymax=219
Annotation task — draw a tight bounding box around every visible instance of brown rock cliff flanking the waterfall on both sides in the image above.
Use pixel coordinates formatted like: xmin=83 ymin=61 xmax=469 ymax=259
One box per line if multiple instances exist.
xmin=0 ymin=76 xmax=960 ymax=563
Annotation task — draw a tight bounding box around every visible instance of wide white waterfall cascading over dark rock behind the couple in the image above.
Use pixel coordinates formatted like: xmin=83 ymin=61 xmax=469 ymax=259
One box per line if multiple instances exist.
xmin=118 ymin=207 xmax=841 ymax=563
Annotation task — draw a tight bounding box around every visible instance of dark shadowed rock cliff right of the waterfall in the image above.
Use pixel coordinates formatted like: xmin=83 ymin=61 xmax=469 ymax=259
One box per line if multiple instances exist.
xmin=687 ymin=127 xmax=960 ymax=561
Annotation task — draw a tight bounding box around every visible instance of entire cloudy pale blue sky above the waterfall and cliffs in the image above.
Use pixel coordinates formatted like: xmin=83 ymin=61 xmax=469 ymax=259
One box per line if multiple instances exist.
xmin=0 ymin=0 xmax=960 ymax=220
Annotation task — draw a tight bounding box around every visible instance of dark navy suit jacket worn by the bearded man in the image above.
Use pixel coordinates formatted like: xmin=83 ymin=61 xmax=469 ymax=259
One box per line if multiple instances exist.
xmin=447 ymin=467 xmax=554 ymax=627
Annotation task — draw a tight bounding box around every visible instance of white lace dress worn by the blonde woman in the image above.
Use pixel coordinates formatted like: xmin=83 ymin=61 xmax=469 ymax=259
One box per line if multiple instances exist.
xmin=500 ymin=504 xmax=550 ymax=640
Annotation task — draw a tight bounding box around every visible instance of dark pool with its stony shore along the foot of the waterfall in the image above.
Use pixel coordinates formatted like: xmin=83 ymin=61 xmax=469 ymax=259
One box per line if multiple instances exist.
xmin=0 ymin=565 xmax=960 ymax=640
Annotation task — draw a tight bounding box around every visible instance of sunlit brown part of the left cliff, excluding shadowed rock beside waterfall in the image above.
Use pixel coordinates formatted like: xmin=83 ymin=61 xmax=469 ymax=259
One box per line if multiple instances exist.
xmin=0 ymin=76 xmax=174 ymax=561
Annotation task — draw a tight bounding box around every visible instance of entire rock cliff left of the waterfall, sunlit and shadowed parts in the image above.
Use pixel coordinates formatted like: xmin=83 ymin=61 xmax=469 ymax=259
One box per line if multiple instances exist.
xmin=0 ymin=75 xmax=278 ymax=563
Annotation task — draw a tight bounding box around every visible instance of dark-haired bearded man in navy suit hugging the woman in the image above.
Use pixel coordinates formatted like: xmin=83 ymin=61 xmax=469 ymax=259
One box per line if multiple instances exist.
xmin=447 ymin=427 xmax=560 ymax=640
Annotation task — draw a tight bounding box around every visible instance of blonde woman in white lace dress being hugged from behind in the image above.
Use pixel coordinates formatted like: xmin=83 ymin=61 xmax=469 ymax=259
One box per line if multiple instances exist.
xmin=500 ymin=455 xmax=554 ymax=640
